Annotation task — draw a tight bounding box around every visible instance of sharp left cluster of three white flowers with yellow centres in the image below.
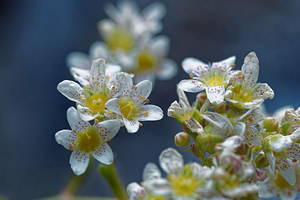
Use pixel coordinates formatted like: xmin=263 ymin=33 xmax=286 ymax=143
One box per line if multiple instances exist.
xmin=55 ymin=59 xmax=163 ymax=175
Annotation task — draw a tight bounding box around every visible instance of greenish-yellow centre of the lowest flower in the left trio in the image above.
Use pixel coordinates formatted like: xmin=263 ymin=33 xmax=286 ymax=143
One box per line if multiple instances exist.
xmin=74 ymin=126 xmax=103 ymax=153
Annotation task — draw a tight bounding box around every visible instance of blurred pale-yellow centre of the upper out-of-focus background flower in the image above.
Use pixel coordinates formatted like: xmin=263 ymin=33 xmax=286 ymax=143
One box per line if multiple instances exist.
xmin=106 ymin=29 xmax=134 ymax=52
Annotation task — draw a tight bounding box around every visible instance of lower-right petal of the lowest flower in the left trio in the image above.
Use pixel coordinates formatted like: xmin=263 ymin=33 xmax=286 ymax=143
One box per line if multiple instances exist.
xmin=93 ymin=143 xmax=114 ymax=165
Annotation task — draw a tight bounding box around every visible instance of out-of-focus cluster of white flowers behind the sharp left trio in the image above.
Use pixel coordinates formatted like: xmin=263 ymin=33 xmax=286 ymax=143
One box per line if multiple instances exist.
xmin=67 ymin=1 xmax=177 ymax=83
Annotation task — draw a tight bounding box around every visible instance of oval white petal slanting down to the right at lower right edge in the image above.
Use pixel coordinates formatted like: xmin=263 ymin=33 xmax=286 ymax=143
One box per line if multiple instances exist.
xmin=276 ymin=158 xmax=296 ymax=185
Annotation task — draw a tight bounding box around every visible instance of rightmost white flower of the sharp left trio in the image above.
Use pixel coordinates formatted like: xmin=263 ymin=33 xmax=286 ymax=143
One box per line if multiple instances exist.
xmin=105 ymin=72 xmax=163 ymax=133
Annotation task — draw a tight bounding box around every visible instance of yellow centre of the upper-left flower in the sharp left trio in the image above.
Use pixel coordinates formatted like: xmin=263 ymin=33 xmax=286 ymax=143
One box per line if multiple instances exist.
xmin=86 ymin=94 xmax=108 ymax=114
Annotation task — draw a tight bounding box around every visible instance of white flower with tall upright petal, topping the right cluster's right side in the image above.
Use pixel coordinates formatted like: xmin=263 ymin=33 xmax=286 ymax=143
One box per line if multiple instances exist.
xmin=224 ymin=52 xmax=274 ymax=110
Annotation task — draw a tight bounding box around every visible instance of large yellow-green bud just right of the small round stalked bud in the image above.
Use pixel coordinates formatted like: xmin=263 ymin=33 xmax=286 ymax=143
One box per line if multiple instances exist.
xmin=195 ymin=135 xmax=224 ymax=154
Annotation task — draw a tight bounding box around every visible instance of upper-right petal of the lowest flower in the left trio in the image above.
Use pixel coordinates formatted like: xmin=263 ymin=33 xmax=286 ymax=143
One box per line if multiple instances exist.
xmin=94 ymin=119 xmax=120 ymax=141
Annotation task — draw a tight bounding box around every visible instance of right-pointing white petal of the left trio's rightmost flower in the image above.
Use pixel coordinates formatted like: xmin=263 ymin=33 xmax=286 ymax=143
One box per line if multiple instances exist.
xmin=138 ymin=105 xmax=163 ymax=121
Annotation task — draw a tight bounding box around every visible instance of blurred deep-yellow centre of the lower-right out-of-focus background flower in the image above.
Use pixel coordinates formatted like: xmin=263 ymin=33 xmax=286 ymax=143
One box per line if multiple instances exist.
xmin=137 ymin=51 xmax=157 ymax=72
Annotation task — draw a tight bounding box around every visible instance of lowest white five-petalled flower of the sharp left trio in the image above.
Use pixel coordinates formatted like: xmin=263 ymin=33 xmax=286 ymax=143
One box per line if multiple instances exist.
xmin=55 ymin=107 xmax=120 ymax=175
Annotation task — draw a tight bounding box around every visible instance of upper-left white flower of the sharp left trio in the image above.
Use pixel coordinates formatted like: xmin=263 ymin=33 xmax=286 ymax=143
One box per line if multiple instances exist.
xmin=57 ymin=59 xmax=121 ymax=121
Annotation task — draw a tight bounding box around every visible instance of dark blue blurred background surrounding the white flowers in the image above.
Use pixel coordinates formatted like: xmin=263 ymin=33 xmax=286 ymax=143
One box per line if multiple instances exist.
xmin=0 ymin=0 xmax=300 ymax=200
